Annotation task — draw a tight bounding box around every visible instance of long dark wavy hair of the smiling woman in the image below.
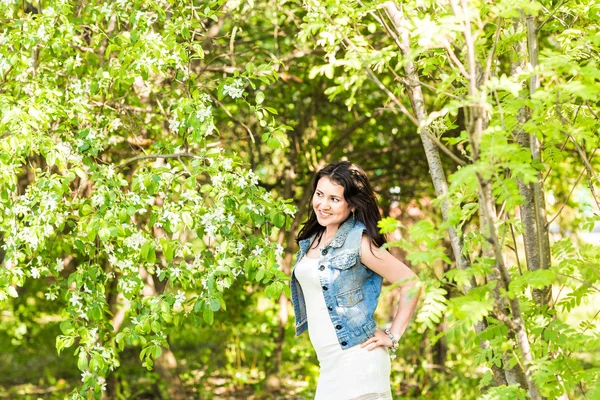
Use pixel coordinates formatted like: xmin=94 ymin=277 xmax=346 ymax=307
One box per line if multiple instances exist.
xmin=296 ymin=161 xmax=386 ymax=247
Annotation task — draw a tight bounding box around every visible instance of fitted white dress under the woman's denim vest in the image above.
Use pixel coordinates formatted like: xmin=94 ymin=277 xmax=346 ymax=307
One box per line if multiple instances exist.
xmin=295 ymin=256 xmax=392 ymax=400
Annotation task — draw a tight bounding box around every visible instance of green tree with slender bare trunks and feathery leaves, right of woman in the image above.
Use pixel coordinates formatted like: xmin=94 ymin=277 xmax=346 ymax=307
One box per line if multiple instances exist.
xmin=303 ymin=1 xmax=598 ymax=399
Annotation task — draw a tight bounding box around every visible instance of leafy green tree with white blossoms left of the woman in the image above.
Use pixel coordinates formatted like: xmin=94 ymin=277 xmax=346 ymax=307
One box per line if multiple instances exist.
xmin=0 ymin=0 xmax=294 ymax=398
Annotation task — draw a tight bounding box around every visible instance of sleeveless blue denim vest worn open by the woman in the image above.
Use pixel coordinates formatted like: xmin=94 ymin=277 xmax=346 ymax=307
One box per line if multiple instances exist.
xmin=290 ymin=217 xmax=383 ymax=350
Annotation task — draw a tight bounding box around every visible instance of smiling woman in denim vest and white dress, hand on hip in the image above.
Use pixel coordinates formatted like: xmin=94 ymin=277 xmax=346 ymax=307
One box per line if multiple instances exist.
xmin=291 ymin=161 xmax=418 ymax=400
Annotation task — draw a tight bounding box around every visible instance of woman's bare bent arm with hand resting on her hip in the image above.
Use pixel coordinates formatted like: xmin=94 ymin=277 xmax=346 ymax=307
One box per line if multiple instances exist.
xmin=360 ymin=234 xmax=421 ymax=350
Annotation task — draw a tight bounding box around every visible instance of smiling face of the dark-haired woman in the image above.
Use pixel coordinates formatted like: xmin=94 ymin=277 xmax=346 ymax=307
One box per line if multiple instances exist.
xmin=313 ymin=176 xmax=352 ymax=229
